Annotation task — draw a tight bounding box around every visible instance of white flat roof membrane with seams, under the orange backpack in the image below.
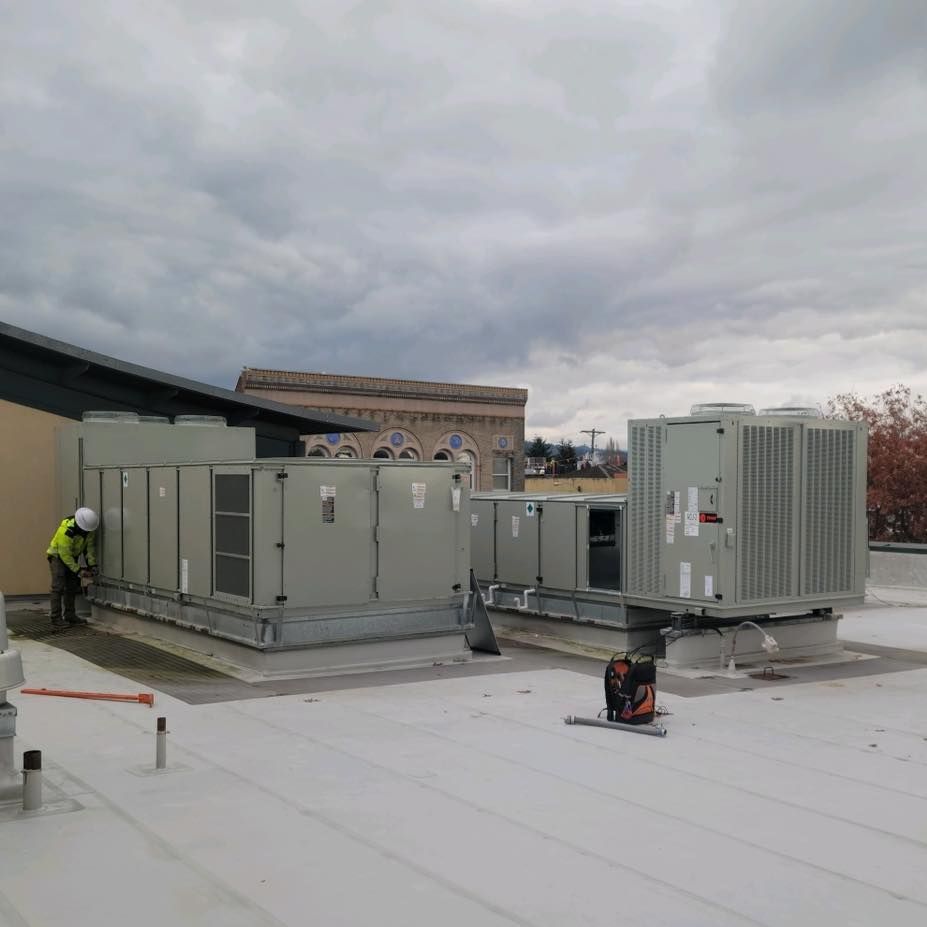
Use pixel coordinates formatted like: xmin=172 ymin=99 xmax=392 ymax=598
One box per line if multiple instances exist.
xmin=0 ymin=603 xmax=927 ymax=927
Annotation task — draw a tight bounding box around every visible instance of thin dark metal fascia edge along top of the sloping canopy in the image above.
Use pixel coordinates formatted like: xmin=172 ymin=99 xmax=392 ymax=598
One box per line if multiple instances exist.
xmin=0 ymin=321 xmax=380 ymax=434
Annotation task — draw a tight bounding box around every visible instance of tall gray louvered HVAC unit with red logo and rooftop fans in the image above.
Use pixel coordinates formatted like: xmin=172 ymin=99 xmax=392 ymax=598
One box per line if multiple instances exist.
xmin=625 ymin=407 xmax=868 ymax=617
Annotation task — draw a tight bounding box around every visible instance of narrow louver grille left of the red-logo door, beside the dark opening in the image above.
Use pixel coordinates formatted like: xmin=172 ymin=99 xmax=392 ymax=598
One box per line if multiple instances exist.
xmin=628 ymin=425 xmax=664 ymax=595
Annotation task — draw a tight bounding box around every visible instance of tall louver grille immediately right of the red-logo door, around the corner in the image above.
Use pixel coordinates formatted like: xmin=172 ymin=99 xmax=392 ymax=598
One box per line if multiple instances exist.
xmin=739 ymin=425 xmax=795 ymax=602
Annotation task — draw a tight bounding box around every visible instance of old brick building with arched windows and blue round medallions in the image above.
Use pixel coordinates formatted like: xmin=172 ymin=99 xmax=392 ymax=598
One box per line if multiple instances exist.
xmin=236 ymin=367 xmax=528 ymax=490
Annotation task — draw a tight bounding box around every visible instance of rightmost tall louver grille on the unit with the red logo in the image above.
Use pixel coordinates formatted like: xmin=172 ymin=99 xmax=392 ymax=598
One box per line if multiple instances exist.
xmin=802 ymin=428 xmax=856 ymax=595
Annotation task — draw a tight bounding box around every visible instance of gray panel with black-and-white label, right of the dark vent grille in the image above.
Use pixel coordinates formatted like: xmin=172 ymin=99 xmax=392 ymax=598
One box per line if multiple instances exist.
xmin=283 ymin=464 xmax=376 ymax=607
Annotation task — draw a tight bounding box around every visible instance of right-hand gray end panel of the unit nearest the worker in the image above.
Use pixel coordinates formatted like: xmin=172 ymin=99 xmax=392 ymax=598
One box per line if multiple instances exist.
xmin=377 ymin=464 xmax=467 ymax=601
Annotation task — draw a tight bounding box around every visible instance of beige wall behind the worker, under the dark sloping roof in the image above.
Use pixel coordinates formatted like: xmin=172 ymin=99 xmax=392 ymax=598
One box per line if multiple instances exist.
xmin=0 ymin=400 xmax=67 ymax=596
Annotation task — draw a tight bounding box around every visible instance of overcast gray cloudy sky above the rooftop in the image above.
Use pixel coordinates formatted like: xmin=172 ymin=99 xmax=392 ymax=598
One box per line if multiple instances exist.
xmin=0 ymin=0 xmax=927 ymax=440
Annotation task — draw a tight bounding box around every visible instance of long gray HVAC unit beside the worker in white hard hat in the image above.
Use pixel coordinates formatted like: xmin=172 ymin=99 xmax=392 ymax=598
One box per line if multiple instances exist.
xmin=59 ymin=423 xmax=470 ymax=666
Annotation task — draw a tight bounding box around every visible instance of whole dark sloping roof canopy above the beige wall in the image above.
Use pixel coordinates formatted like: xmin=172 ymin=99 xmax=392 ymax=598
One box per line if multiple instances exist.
xmin=0 ymin=322 xmax=379 ymax=457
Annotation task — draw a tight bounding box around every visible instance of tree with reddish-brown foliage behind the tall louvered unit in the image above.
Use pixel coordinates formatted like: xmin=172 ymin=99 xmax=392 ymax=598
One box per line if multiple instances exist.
xmin=827 ymin=385 xmax=927 ymax=543
